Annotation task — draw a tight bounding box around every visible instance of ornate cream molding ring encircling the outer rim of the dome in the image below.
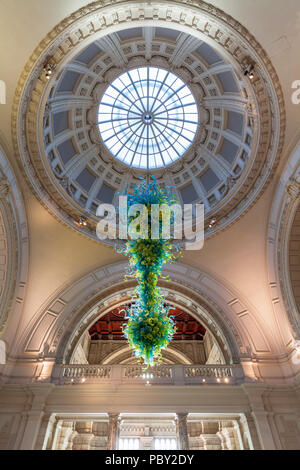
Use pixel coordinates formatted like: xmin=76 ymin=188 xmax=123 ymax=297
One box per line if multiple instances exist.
xmin=12 ymin=0 xmax=285 ymax=238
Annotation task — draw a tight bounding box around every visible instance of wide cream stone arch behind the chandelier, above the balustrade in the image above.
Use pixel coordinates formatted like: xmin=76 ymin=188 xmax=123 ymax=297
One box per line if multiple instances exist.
xmin=19 ymin=262 xmax=272 ymax=380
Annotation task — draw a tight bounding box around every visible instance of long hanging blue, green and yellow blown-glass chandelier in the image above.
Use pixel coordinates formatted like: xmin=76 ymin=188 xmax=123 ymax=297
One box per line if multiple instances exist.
xmin=117 ymin=180 xmax=181 ymax=366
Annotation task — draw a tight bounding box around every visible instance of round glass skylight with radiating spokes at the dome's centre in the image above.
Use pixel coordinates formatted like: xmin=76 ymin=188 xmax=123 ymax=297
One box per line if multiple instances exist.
xmin=98 ymin=67 xmax=198 ymax=170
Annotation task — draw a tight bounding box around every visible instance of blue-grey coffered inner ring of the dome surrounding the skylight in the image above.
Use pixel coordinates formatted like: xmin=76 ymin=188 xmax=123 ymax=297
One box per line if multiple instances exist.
xmin=44 ymin=28 xmax=253 ymax=213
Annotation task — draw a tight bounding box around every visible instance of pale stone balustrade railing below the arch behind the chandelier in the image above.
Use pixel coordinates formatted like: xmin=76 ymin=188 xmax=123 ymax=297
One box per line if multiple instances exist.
xmin=51 ymin=364 xmax=245 ymax=386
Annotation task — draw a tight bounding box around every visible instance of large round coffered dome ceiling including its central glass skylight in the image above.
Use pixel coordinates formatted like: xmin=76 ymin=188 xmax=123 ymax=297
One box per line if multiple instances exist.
xmin=13 ymin=0 xmax=284 ymax=238
